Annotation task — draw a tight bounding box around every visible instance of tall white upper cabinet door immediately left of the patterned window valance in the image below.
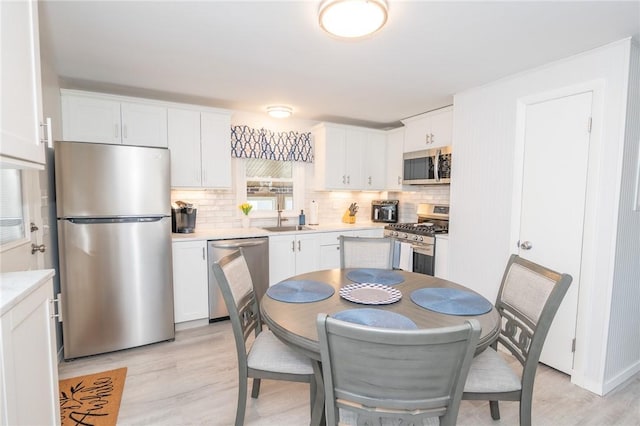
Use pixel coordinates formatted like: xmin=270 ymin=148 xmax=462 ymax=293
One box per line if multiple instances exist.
xmin=200 ymin=112 xmax=231 ymax=188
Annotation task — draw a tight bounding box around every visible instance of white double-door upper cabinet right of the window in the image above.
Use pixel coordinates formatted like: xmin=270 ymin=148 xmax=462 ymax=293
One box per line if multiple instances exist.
xmin=313 ymin=123 xmax=386 ymax=191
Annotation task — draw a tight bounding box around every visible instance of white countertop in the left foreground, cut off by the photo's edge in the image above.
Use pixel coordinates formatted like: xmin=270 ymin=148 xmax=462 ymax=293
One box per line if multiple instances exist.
xmin=0 ymin=269 xmax=55 ymax=315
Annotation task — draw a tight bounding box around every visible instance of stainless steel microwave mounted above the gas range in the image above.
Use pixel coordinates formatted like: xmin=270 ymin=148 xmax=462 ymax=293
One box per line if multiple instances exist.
xmin=402 ymin=146 xmax=451 ymax=185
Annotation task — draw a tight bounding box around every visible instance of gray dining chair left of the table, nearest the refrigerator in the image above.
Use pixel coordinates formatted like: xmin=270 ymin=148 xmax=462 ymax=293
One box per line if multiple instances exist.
xmin=213 ymin=249 xmax=323 ymax=426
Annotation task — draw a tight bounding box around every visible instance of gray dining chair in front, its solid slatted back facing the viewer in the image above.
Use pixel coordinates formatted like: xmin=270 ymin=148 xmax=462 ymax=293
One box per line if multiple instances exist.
xmin=317 ymin=314 xmax=480 ymax=426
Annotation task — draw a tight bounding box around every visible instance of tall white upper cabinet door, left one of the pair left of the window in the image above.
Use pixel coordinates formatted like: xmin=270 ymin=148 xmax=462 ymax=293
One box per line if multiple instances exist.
xmin=167 ymin=109 xmax=202 ymax=187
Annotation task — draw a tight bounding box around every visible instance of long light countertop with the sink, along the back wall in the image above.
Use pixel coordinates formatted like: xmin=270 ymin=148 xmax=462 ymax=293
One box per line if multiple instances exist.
xmin=171 ymin=222 xmax=385 ymax=242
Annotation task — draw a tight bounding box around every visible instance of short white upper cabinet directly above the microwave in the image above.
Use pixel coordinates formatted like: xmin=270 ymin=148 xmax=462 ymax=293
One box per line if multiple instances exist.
xmin=402 ymin=106 xmax=453 ymax=152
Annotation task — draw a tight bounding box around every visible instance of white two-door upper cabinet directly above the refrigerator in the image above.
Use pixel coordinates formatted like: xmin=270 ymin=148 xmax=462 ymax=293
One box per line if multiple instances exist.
xmin=61 ymin=89 xmax=167 ymax=148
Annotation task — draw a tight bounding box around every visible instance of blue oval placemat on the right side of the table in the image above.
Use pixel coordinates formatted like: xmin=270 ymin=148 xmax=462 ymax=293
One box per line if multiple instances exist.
xmin=411 ymin=288 xmax=493 ymax=315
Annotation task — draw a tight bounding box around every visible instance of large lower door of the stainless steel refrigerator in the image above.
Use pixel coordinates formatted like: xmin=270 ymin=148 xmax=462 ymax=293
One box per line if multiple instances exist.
xmin=58 ymin=218 xmax=175 ymax=359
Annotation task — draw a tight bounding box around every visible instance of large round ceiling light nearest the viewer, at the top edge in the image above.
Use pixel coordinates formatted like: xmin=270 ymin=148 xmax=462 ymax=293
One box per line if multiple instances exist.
xmin=318 ymin=0 xmax=388 ymax=38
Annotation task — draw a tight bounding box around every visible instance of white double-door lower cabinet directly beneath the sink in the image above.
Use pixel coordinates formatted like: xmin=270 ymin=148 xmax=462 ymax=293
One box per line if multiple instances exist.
xmin=269 ymin=233 xmax=320 ymax=285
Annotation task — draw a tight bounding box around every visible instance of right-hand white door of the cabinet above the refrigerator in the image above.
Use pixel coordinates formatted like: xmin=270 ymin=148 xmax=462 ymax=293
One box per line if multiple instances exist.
xmin=120 ymin=102 xmax=167 ymax=148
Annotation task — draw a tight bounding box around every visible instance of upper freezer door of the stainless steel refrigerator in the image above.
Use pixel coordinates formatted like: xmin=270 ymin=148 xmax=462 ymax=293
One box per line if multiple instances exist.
xmin=54 ymin=142 xmax=171 ymax=218
